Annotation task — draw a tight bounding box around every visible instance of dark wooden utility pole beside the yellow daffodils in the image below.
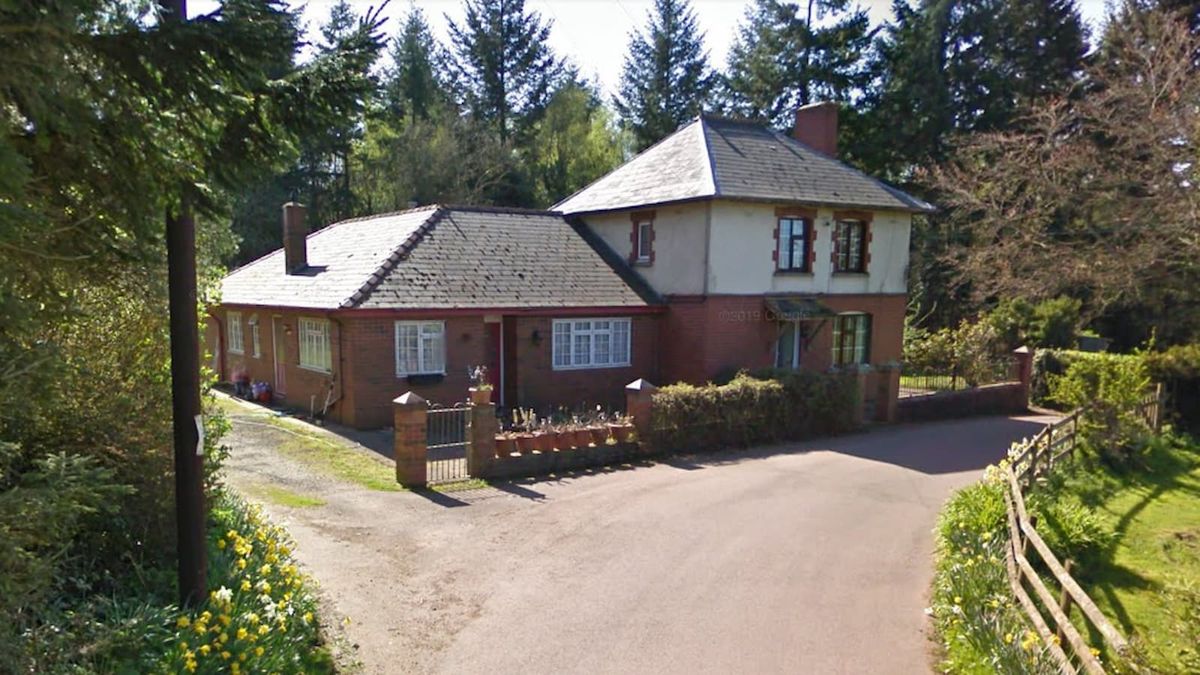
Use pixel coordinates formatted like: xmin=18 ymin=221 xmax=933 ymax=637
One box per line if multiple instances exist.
xmin=158 ymin=0 xmax=209 ymax=607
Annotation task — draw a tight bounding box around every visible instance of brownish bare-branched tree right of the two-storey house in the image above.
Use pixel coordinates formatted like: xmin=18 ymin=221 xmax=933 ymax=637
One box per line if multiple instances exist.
xmin=934 ymin=11 xmax=1200 ymax=342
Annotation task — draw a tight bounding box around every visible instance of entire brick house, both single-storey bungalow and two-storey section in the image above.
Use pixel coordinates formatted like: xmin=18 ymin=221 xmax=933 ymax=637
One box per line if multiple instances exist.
xmin=208 ymin=103 xmax=932 ymax=428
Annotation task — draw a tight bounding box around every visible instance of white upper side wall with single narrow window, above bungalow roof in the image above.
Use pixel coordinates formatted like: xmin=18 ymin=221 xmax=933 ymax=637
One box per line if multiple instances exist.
xmin=583 ymin=202 xmax=705 ymax=295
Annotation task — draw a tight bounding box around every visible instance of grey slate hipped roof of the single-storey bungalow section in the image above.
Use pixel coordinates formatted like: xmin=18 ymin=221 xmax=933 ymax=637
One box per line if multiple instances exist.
xmin=221 ymin=207 xmax=659 ymax=310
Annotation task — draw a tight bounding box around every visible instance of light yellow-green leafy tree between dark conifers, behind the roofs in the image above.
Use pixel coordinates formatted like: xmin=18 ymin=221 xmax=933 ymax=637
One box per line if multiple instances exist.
xmin=527 ymin=83 xmax=624 ymax=205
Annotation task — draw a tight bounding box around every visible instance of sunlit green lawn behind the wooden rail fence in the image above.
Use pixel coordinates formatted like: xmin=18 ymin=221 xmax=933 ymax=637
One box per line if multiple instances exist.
xmin=1039 ymin=432 xmax=1200 ymax=673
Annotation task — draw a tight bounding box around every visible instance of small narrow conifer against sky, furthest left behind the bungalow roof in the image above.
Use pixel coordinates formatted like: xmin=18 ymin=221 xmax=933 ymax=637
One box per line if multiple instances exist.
xmin=383 ymin=7 xmax=446 ymax=120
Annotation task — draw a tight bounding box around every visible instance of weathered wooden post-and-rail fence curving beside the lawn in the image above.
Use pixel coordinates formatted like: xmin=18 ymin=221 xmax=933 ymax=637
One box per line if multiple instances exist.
xmin=1004 ymin=386 xmax=1162 ymax=675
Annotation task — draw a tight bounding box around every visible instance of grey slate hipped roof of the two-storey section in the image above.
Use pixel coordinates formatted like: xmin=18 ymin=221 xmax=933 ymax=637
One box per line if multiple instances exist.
xmin=553 ymin=115 xmax=934 ymax=214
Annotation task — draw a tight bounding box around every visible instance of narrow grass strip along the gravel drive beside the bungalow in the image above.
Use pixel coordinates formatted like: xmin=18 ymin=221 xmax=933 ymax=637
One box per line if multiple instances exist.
xmin=217 ymin=398 xmax=403 ymax=492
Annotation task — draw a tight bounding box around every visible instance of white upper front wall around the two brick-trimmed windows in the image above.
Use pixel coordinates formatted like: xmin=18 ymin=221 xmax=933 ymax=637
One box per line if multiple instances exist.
xmin=700 ymin=201 xmax=912 ymax=294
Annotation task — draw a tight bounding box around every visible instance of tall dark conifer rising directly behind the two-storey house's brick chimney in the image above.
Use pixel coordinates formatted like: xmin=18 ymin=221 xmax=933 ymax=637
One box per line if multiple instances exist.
xmin=725 ymin=0 xmax=875 ymax=127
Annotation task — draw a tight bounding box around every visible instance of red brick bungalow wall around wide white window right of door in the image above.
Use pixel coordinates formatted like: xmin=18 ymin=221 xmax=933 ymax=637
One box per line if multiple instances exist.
xmin=517 ymin=316 xmax=659 ymax=413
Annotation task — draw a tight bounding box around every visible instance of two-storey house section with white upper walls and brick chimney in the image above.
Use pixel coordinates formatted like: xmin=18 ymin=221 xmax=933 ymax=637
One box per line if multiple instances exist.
xmin=554 ymin=103 xmax=932 ymax=418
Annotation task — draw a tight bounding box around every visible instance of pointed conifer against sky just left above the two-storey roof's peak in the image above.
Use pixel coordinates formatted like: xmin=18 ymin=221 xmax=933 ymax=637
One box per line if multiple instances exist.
xmin=616 ymin=0 xmax=715 ymax=151
